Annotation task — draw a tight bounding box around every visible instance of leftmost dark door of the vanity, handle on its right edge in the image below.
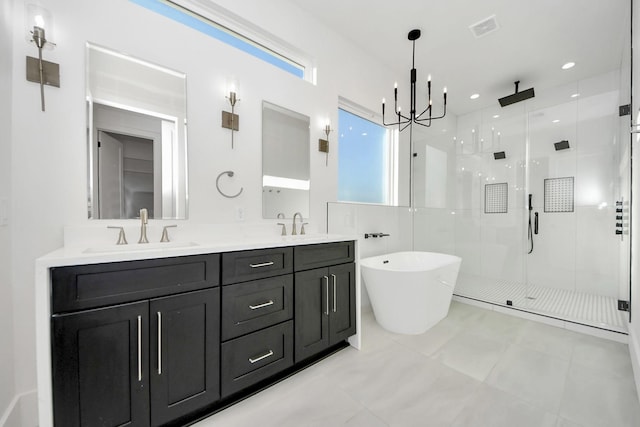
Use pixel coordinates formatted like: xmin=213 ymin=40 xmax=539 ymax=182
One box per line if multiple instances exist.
xmin=52 ymin=302 xmax=149 ymax=427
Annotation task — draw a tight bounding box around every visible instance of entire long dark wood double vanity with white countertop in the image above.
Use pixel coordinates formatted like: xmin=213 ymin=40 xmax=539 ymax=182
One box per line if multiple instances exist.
xmin=36 ymin=235 xmax=359 ymax=427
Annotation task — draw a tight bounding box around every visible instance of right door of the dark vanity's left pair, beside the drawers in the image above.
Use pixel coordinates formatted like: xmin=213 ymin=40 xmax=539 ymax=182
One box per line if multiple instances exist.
xmin=150 ymin=288 xmax=220 ymax=426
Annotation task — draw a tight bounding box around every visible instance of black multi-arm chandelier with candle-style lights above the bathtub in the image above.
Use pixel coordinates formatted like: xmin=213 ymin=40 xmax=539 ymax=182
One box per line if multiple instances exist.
xmin=382 ymin=30 xmax=447 ymax=131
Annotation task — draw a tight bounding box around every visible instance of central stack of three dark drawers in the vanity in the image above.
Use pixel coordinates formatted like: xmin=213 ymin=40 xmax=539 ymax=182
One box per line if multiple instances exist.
xmin=220 ymin=247 xmax=294 ymax=398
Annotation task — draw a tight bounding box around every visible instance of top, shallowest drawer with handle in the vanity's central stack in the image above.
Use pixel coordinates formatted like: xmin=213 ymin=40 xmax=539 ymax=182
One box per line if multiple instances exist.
xmin=222 ymin=247 xmax=293 ymax=285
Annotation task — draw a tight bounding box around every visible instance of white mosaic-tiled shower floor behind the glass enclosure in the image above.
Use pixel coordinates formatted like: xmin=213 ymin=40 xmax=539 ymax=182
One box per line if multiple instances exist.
xmin=455 ymin=275 xmax=628 ymax=333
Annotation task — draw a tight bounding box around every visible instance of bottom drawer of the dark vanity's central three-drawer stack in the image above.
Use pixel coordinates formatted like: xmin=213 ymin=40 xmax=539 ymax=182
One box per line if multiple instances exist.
xmin=220 ymin=320 xmax=293 ymax=397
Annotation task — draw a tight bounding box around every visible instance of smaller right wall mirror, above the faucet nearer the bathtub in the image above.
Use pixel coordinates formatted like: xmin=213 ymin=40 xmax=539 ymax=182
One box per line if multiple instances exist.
xmin=262 ymin=101 xmax=310 ymax=218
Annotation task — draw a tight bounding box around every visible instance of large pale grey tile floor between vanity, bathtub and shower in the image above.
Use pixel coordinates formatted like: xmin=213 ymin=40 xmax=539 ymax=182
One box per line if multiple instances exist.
xmin=196 ymin=302 xmax=640 ymax=427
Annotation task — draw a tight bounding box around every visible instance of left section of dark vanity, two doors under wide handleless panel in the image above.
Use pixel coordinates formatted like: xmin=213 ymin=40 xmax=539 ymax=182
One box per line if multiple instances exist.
xmin=52 ymin=255 xmax=220 ymax=427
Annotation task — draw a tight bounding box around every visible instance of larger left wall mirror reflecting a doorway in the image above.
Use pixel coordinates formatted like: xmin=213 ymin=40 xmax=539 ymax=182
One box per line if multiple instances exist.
xmin=86 ymin=43 xmax=188 ymax=219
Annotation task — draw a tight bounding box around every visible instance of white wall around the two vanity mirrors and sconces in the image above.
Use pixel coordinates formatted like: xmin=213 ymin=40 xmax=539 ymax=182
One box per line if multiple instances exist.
xmin=6 ymin=0 xmax=397 ymax=422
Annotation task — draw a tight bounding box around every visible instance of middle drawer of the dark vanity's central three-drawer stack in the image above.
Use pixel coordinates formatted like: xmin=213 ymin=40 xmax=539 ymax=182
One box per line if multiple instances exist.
xmin=222 ymin=274 xmax=293 ymax=341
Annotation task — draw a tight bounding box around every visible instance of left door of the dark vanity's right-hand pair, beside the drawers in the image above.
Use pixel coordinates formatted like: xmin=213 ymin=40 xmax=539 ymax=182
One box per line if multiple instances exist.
xmin=294 ymin=268 xmax=329 ymax=363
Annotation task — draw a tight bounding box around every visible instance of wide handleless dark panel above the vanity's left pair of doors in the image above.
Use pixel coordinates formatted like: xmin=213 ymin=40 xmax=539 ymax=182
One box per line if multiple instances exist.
xmin=51 ymin=254 xmax=220 ymax=313
